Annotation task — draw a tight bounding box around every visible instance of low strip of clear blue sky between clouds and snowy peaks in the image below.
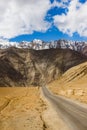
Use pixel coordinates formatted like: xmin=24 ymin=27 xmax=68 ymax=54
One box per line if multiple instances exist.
xmin=10 ymin=27 xmax=87 ymax=42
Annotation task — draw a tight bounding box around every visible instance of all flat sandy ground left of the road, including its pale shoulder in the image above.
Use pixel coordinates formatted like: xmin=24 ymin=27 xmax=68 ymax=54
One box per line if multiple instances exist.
xmin=0 ymin=87 xmax=68 ymax=130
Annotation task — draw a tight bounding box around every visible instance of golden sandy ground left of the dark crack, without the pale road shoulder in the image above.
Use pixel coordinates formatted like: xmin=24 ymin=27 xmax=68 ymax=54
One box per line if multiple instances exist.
xmin=0 ymin=87 xmax=46 ymax=130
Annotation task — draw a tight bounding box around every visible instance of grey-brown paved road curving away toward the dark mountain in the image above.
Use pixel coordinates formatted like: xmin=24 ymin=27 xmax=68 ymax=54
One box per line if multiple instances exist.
xmin=42 ymin=86 xmax=87 ymax=130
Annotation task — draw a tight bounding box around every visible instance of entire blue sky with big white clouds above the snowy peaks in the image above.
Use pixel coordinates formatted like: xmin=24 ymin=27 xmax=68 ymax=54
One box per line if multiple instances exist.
xmin=0 ymin=0 xmax=87 ymax=42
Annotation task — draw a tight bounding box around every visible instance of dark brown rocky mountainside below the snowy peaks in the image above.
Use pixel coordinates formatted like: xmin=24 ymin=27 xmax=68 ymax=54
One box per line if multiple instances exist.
xmin=0 ymin=47 xmax=87 ymax=87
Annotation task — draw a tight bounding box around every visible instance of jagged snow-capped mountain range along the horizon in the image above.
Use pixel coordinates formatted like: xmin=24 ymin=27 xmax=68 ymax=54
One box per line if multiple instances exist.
xmin=0 ymin=39 xmax=87 ymax=55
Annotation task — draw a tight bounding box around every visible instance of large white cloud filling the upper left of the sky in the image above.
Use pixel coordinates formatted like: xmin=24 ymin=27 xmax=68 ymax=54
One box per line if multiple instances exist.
xmin=0 ymin=0 xmax=51 ymax=38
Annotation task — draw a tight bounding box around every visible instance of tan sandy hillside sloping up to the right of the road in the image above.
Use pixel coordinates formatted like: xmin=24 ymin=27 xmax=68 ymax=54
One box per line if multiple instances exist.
xmin=48 ymin=62 xmax=87 ymax=103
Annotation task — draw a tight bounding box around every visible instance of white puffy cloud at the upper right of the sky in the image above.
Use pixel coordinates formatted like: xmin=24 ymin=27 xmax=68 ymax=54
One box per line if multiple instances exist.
xmin=54 ymin=0 xmax=87 ymax=37
